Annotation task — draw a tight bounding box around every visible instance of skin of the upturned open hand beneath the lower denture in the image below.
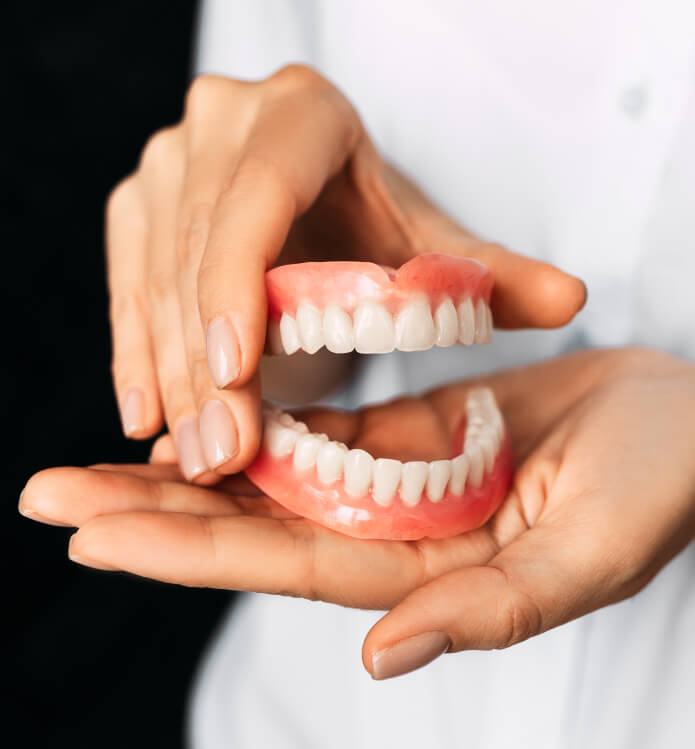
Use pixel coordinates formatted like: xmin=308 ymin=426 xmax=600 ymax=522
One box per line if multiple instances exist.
xmin=20 ymin=349 xmax=695 ymax=673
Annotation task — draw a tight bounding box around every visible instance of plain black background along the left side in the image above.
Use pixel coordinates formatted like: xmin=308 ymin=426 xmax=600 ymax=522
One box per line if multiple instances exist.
xmin=0 ymin=0 xmax=230 ymax=749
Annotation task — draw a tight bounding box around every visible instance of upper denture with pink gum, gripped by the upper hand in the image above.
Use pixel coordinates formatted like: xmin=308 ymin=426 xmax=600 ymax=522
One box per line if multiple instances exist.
xmin=266 ymin=254 xmax=492 ymax=354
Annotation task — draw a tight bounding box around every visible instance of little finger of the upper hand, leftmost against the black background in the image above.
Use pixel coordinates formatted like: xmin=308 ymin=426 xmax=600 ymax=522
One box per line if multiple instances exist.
xmin=106 ymin=177 xmax=162 ymax=438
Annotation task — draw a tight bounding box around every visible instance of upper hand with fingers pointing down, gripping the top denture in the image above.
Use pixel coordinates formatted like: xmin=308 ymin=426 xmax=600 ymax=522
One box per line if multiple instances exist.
xmin=106 ymin=65 xmax=585 ymax=483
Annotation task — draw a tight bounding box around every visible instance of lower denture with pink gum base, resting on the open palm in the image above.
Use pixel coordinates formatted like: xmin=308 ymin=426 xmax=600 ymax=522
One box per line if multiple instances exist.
xmin=247 ymin=388 xmax=511 ymax=540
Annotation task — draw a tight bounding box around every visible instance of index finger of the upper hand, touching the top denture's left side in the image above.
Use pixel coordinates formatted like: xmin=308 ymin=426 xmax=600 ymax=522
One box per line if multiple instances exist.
xmin=198 ymin=69 xmax=362 ymax=387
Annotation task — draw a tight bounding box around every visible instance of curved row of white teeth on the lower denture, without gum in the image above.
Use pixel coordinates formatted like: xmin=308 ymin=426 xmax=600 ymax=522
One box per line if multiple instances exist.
xmin=264 ymin=387 xmax=504 ymax=507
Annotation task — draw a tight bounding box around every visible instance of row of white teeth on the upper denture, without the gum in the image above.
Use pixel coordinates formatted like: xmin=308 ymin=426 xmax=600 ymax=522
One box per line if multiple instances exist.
xmin=268 ymin=297 xmax=492 ymax=354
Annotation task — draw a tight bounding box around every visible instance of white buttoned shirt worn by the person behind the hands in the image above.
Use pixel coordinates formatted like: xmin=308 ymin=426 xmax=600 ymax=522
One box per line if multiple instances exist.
xmin=191 ymin=0 xmax=695 ymax=749
